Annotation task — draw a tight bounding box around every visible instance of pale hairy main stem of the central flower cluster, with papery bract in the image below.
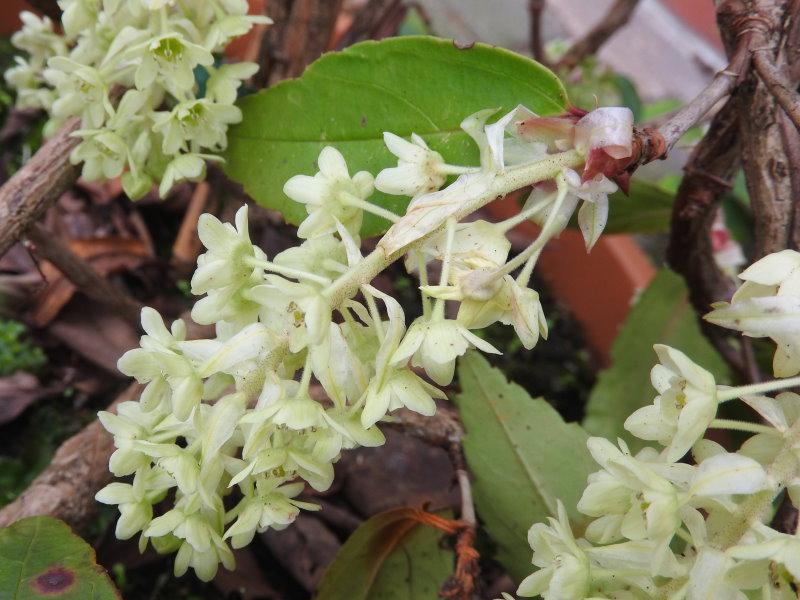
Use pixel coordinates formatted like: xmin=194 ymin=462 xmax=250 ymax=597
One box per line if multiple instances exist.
xmin=323 ymin=150 xmax=586 ymax=306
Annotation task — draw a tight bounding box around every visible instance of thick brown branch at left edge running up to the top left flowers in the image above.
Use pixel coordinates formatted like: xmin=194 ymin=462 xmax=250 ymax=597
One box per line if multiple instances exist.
xmin=0 ymin=118 xmax=81 ymax=256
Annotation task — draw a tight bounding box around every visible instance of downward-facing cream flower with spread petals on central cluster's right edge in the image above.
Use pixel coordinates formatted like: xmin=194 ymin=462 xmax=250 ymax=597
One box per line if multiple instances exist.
xmin=391 ymin=317 xmax=501 ymax=385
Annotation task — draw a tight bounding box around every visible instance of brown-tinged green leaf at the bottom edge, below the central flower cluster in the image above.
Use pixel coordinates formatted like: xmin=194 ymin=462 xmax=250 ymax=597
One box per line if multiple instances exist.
xmin=315 ymin=508 xmax=454 ymax=600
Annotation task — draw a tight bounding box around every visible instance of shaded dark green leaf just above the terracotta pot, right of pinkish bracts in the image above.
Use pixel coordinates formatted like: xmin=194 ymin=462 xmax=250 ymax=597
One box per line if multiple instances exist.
xmin=604 ymin=180 xmax=675 ymax=233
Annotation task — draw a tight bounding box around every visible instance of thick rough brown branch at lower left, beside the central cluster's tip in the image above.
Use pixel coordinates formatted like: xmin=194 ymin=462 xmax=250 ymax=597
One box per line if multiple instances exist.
xmin=0 ymin=383 xmax=141 ymax=531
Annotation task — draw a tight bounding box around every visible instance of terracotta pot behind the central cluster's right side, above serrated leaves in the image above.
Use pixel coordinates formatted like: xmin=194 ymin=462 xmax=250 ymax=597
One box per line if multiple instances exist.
xmin=487 ymin=196 xmax=655 ymax=366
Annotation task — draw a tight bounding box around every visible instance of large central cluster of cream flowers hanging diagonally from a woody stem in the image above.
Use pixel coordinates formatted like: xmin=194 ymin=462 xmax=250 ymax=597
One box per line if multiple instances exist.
xmin=97 ymin=108 xmax=631 ymax=579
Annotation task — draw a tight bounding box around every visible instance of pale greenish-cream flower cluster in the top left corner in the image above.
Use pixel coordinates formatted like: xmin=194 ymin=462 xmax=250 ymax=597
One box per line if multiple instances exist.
xmin=5 ymin=0 xmax=270 ymax=199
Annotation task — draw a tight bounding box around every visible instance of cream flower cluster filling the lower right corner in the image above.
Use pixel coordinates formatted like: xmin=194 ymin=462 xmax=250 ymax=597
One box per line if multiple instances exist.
xmin=518 ymin=251 xmax=800 ymax=600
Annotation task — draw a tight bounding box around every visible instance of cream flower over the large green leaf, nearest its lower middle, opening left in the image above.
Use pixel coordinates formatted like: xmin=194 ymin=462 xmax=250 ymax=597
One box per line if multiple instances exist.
xmin=375 ymin=132 xmax=447 ymax=197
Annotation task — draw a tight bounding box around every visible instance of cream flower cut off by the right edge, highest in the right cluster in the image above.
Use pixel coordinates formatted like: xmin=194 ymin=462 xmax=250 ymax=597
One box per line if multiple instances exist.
xmin=704 ymin=250 xmax=800 ymax=377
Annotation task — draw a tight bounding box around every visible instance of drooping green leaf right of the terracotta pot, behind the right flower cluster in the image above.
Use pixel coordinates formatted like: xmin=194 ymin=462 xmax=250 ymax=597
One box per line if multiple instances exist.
xmin=583 ymin=269 xmax=731 ymax=450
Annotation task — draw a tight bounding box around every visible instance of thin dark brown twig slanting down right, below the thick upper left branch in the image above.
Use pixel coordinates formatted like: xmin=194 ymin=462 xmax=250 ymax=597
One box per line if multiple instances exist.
xmin=25 ymin=223 xmax=142 ymax=325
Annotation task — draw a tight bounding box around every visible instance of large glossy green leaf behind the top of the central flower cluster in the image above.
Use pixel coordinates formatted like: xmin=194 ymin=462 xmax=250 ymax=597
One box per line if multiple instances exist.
xmin=225 ymin=36 xmax=567 ymax=235
